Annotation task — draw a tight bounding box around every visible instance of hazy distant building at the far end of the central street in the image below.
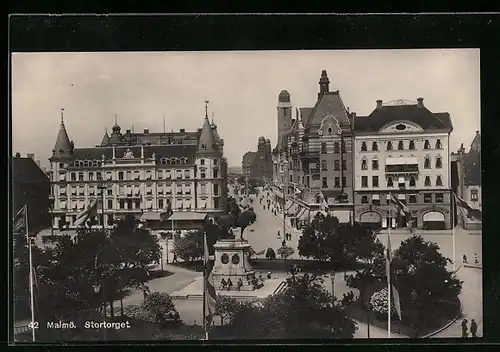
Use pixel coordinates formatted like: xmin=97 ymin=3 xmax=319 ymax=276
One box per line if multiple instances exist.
xmin=242 ymin=137 xmax=273 ymax=182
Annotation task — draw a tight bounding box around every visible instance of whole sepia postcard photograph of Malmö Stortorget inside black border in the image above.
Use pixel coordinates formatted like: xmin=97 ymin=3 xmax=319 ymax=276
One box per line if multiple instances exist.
xmin=11 ymin=48 xmax=483 ymax=343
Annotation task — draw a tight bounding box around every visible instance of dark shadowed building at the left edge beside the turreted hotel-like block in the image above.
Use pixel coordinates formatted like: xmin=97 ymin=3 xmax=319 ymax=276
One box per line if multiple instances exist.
xmin=12 ymin=153 xmax=50 ymax=231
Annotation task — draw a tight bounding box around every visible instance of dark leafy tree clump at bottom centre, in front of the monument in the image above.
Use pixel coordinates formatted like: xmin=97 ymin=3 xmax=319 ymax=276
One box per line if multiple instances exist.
xmin=221 ymin=274 xmax=356 ymax=339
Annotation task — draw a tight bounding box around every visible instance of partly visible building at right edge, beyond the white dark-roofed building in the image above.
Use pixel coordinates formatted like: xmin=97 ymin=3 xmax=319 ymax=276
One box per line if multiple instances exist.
xmin=451 ymin=131 xmax=482 ymax=227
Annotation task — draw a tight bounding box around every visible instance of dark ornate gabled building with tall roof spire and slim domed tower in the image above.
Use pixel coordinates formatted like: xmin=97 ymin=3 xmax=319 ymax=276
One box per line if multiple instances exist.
xmin=273 ymin=71 xmax=355 ymax=222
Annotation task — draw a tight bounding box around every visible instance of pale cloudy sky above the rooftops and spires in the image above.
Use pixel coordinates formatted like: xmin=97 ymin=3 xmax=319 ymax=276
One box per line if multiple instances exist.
xmin=12 ymin=49 xmax=480 ymax=166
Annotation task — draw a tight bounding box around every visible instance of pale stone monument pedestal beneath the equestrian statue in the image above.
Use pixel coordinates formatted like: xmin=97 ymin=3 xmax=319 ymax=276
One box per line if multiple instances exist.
xmin=212 ymin=233 xmax=257 ymax=291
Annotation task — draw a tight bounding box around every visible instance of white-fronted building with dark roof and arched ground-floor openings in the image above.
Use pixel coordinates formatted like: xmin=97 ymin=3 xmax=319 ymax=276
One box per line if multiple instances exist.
xmin=353 ymin=98 xmax=453 ymax=229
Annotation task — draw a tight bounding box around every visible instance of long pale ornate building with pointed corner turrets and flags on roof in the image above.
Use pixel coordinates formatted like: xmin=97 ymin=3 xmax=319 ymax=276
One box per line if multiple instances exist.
xmin=49 ymin=107 xmax=227 ymax=228
